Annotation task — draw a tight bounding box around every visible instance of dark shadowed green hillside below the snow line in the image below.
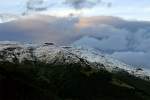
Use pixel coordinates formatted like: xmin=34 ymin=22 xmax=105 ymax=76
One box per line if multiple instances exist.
xmin=0 ymin=61 xmax=150 ymax=100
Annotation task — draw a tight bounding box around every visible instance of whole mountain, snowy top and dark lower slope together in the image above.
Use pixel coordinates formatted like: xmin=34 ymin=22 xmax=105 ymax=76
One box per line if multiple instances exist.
xmin=0 ymin=41 xmax=150 ymax=100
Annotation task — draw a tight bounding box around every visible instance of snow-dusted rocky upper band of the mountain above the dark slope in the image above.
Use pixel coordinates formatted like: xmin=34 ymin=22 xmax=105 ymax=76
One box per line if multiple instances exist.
xmin=0 ymin=41 xmax=150 ymax=79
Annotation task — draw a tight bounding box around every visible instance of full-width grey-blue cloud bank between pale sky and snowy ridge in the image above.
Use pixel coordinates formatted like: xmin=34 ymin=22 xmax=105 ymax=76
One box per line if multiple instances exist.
xmin=0 ymin=15 xmax=150 ymax=68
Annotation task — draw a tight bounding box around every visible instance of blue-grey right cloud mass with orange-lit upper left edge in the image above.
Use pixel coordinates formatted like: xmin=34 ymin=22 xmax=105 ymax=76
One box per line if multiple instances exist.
xmin=74 ymin=17 xmax=150 ymax=68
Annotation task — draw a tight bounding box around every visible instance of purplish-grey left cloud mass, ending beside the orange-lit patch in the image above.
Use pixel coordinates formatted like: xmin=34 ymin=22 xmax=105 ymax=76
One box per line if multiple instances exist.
xmin=0 ymin=16 xmax=78 ymax=45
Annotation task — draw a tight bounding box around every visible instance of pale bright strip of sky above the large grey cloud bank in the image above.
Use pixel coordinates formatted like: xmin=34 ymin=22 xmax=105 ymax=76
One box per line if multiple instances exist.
xmin=0 ymin=0 xmax=150 ymax=21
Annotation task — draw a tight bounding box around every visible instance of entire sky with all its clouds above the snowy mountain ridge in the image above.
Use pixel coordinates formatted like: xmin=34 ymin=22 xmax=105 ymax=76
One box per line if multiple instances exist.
xmin=0 ymin=0 xmax=150 ymax=69
